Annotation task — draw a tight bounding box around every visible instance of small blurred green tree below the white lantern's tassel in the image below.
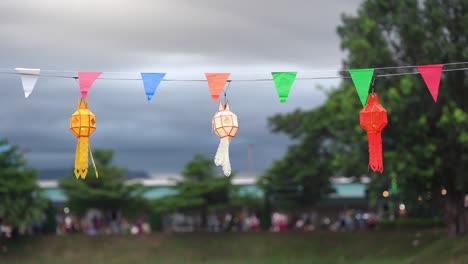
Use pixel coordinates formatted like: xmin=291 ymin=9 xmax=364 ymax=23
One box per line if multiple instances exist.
xmin=154 ymin=154 xmax=233 ymax=228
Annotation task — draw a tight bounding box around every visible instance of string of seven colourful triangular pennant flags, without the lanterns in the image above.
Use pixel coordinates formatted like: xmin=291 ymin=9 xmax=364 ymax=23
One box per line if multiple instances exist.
xmin=0 ymin=62 xmax=468 ymax=103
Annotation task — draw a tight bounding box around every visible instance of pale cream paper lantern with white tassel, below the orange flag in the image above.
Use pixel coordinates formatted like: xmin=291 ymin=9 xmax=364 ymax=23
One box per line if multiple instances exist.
xmin=212 ymin=101 xmax=239 ymax=176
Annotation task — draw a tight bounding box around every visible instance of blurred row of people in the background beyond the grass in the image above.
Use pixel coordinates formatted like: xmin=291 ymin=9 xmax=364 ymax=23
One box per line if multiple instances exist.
xmin=54 ymin=208 xmax=377 ymax=235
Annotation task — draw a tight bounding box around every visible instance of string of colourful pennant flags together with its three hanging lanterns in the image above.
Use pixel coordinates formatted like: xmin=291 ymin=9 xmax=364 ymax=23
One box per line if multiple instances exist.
xmin=0 ymin=62 xmax=468 ymax=179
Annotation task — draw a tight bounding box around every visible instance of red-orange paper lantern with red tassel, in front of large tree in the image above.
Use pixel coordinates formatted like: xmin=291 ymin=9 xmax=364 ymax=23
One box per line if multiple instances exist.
xmin=359 ymin=93 xmax=388 ymax=173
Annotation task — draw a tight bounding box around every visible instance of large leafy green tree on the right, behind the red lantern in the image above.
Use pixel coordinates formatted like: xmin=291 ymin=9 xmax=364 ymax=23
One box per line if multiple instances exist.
xmin=264 ymin=0 xmax=468 ymax=236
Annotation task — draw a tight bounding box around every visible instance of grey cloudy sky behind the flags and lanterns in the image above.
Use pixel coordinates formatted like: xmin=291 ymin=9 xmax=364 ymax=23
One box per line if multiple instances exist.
xmin=0 ymin=0 xmax=360 ymax=175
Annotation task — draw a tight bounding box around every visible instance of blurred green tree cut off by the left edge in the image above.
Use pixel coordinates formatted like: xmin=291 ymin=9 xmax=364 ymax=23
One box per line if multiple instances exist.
xmin=0 ymin=139 xmax=47 ymax=233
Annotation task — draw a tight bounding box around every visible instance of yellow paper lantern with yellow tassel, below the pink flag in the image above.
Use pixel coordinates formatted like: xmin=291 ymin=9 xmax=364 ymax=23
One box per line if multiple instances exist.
xmin=70 ymin=98 xmax=98 ymax=179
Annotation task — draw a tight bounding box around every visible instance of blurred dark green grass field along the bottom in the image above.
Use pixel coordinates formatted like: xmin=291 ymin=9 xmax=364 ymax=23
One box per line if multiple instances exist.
xmin=0 ymin=230 xmax=468 ymax=264
